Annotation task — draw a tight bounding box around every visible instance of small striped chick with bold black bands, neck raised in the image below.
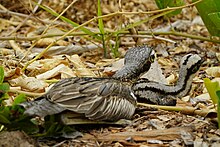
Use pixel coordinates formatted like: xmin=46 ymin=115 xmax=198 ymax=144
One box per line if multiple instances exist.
xmin=132 ymin=54 xmax=204 ymax=106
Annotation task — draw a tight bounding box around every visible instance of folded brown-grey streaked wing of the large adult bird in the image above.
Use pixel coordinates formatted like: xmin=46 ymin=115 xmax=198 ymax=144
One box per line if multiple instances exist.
xmin=45 ymin=77 xmax=136 ymax=120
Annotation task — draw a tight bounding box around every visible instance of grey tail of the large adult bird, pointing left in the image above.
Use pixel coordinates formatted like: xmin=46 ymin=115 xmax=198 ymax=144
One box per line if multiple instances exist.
xmin=19 ymin=98 xmax=65 ymax=117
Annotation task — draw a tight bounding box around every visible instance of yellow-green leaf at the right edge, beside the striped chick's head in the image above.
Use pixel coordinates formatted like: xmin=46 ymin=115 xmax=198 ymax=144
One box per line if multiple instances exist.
xmin=204 ymin=78 xmax=220 ymax=104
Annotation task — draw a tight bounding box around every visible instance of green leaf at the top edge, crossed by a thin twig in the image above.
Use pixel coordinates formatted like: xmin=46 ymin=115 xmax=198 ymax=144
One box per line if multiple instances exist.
xmin=155 ymin=0 xmax=184 ymax=17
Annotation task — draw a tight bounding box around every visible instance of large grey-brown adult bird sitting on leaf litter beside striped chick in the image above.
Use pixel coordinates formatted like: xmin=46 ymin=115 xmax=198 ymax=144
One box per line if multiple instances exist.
xmin=20 ymin=46 xmax=154 ymax=121
